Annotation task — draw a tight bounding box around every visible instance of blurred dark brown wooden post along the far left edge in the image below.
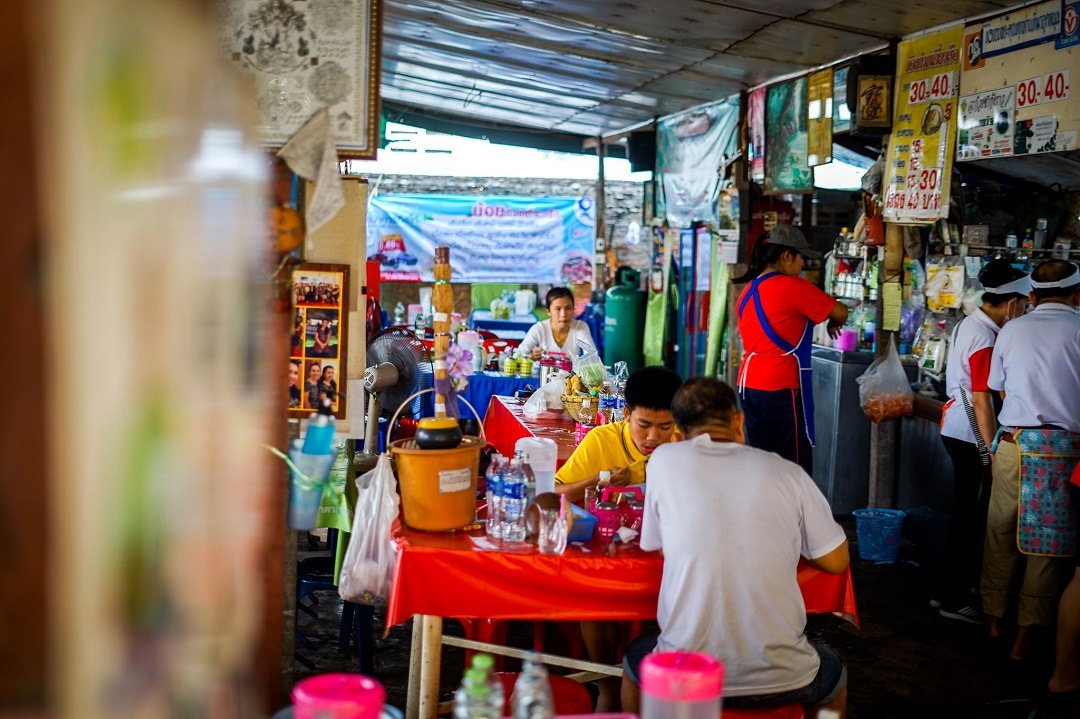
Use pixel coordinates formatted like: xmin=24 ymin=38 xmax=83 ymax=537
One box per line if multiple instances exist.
xmin=0 ymin=0 xmax=46 ymax=703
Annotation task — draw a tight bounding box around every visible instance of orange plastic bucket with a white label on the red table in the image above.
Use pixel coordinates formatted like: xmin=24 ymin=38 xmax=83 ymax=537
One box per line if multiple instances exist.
xmin=390 ymin=436 xmax=487 ymax=532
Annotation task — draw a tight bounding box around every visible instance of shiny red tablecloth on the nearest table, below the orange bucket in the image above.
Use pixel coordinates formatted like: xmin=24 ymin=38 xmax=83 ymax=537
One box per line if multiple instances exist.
xmin=387 ymin=526 xmax=858 ymax=627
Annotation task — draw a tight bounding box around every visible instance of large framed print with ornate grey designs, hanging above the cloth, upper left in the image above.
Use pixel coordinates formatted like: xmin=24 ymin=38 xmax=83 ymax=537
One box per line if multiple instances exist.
xmin=218 ymin=0 xmax=382 ymax=160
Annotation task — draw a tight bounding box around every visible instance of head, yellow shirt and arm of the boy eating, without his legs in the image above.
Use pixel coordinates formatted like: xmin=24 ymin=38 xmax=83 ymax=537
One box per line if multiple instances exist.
xmin=555 ymin=367 xmax=683 ymax=504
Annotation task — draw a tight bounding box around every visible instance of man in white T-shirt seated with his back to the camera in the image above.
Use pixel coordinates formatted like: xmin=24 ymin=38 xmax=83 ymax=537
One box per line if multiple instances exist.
xmin=622 ymin=378 xmax=848 ymax=717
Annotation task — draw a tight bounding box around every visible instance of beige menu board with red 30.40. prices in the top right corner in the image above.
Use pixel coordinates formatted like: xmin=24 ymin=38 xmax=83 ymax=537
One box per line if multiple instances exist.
xmin=957 ymin=0 xmax=1080 ymax=160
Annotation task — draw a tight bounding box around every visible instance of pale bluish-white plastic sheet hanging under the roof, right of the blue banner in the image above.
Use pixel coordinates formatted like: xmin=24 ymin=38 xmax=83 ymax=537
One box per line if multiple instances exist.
xmin=657 ymin=96 xmax=739 ymax=227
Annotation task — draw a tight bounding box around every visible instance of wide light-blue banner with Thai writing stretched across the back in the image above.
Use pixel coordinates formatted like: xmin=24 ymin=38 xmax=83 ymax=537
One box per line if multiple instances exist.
xmin=367 ymin=194 xmax=596 ymax=285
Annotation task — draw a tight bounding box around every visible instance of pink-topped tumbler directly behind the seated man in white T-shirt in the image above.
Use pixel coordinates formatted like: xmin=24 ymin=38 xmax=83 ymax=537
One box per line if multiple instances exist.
xmin=640 ymin=652 xmax=724 ymax=719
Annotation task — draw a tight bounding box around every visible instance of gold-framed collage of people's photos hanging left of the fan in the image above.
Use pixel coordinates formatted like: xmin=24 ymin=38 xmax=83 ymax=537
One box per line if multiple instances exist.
xmin=288 ymin=262 xmax=349 ymax=419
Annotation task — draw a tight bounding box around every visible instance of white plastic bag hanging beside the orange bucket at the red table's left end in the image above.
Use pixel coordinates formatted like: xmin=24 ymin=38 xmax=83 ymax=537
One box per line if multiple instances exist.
xmin=338 ymin=455 xmax=399 ymax=605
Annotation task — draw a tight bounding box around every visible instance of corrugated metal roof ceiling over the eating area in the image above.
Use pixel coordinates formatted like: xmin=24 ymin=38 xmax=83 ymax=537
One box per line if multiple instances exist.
xmin=382 ymin=0 xmax=1017 ymax=137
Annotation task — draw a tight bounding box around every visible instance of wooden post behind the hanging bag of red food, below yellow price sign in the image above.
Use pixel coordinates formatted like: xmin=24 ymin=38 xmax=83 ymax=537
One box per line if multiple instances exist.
xmin=869 ymin=223 xmax=904 ymax=507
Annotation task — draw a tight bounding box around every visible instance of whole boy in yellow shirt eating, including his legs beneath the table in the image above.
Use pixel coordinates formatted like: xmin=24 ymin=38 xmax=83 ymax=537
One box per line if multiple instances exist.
xmin=555 ymin=360 xmax=683 ymax=714
